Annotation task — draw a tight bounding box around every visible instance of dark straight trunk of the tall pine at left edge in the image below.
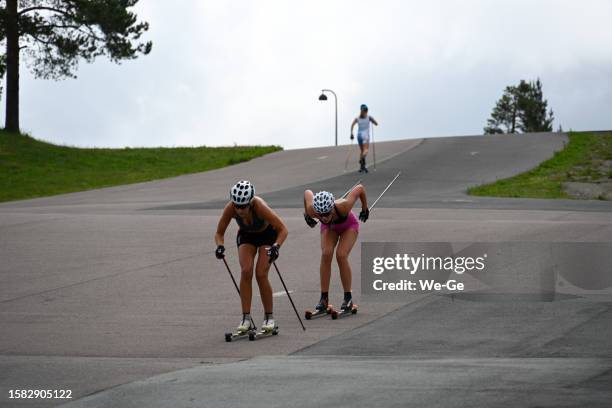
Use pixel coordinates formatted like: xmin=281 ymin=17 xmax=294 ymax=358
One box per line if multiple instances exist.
xmin=5 ymin=0 xmax=19 ymax=132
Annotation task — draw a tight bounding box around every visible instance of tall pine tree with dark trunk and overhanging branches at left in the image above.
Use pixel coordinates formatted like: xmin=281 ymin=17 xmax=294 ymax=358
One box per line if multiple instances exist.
xmin=0 ymin=0 xmax=152 ymax=132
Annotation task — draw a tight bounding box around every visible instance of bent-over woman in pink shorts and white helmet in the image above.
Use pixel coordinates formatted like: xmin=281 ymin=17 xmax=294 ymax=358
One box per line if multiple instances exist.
xmin=304 ymin=184 xmax=370 ymax=313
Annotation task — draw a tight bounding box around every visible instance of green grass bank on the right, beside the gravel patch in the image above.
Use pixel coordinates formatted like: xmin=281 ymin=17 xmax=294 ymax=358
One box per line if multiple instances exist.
xmin=468 ymin=132 xmax=612 ymax=198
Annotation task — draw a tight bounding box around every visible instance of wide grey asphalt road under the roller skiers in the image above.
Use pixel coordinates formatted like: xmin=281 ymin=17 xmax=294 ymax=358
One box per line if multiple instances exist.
xmin=0 ymin=134 xmax=612 ymax=407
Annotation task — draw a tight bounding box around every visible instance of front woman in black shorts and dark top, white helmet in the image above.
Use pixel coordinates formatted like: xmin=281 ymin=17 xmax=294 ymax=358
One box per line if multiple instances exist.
xmin=215 ymin=180 xmax=288 ymax=333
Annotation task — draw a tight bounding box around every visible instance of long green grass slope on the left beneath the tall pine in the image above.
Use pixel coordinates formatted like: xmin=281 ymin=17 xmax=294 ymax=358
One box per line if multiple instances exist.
xmin=0 ymin=130 xmax=281 ymax=202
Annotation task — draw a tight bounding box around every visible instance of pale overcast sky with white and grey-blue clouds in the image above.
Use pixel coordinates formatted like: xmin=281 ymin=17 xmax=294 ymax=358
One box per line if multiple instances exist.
xmin=7 ymin=0 xmax=612 ymax=148
